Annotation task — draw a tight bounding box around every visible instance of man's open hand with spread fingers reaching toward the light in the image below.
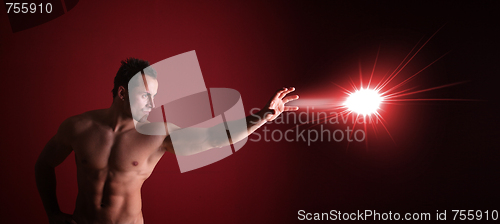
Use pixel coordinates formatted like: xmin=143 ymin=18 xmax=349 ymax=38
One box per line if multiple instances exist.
xmin=262 ymin=87 xmax=299 ymax=121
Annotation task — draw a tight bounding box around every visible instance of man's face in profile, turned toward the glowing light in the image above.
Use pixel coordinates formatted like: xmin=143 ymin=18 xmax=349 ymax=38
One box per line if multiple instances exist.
xmin=129 ymin=75 xmax=158 ymax=122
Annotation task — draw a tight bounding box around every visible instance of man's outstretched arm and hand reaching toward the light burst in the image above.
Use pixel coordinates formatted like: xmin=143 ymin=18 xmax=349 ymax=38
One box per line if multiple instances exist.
xmin=164 ymin=87 xmax=299 ymax=155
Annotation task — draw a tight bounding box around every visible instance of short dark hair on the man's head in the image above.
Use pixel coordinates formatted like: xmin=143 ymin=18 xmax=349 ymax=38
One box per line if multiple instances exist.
xmin=111 ymin=58 xmax=157 ymax=98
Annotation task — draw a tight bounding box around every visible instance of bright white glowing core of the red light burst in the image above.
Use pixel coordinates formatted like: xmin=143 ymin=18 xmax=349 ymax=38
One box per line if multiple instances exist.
xmin=343 ymin=89 xmax=383 ymax=116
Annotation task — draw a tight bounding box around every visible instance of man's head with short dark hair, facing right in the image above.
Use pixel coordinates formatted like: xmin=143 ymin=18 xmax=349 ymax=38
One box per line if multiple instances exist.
xmin=112 ymin=58 xmax=158 ymax=121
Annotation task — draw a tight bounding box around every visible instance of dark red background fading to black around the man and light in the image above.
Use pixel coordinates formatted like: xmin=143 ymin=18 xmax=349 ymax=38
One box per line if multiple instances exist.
xmin=0 ymin=1 xmax=500 ymax=223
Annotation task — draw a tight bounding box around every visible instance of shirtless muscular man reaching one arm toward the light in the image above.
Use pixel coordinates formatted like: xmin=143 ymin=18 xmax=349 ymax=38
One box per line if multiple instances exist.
xmin=35 ymin=58 xmax=298 ymax=224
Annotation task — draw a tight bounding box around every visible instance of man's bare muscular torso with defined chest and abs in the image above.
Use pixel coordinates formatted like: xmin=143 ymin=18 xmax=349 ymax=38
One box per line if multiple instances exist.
xmin=71 ymin=111 xmax=170 ymax=224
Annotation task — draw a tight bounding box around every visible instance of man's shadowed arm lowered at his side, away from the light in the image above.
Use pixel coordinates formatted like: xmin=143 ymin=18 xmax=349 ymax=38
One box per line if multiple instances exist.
xmin=35 ymin=120 xmax=74 ymax=224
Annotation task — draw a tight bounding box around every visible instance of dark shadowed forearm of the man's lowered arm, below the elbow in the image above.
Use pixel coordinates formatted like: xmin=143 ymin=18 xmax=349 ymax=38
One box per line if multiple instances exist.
xmin=35 ymin=162 xmax=61 ymax=216
